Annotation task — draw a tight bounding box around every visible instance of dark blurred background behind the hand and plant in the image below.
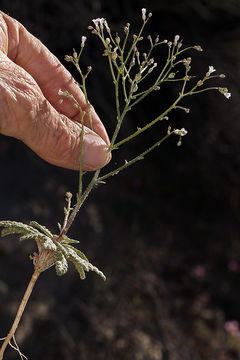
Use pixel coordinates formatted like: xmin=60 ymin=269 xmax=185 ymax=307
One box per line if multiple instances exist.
xmin=0 ymin=0 xmax=240 ymax=360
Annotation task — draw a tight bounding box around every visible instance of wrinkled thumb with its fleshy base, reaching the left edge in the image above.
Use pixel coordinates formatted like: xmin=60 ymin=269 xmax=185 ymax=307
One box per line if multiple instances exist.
xmin=0 ymin=53 xmax=110 ymax=171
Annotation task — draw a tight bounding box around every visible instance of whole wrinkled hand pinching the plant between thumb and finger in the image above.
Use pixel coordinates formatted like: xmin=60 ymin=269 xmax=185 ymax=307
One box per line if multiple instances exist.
xmin=0 ymin=12 xmax=110 ymax=171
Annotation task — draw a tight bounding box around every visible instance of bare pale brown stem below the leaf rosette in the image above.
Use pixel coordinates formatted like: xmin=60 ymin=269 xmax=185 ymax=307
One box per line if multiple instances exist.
xmin=0 ymin=269 xmax=40 ymax=360
